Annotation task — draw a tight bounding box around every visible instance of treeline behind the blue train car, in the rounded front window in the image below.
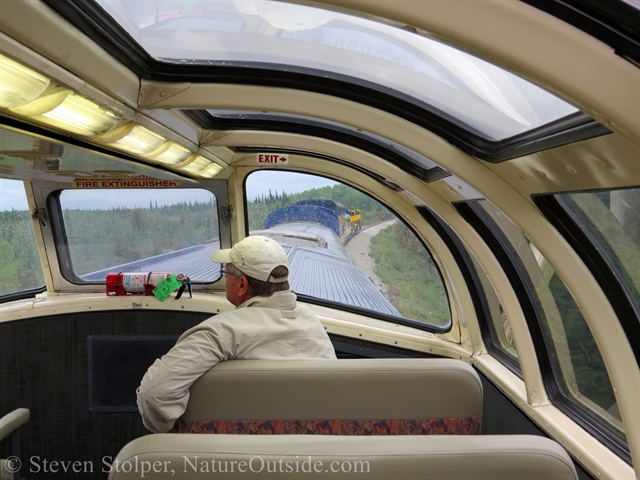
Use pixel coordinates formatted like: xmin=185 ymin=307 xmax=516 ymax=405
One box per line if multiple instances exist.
xmin=247 ymin=184 xmax=394 ymax=230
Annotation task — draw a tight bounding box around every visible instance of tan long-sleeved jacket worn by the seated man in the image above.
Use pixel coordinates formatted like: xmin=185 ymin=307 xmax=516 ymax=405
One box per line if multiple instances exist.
xmin=137 ymin=290 xmax=336 ymax=433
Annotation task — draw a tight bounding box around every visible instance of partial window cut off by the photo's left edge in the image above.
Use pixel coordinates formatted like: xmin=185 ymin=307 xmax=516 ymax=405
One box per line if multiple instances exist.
xmin=0 ymin=179 xmax=44 ymax=296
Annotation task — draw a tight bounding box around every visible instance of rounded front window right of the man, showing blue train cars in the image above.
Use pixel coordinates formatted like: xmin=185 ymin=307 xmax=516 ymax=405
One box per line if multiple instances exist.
xmin=246 ymin=170 xmax=451 ymax=328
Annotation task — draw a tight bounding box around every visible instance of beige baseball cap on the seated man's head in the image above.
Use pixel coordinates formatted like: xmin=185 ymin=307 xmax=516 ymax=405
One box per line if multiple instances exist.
xmin=211 ymin=235 xmax=289 ymax=283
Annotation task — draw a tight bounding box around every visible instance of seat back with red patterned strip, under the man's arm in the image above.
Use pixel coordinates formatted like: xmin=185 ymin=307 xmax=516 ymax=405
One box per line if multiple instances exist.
xmin=178 ymin=359 xmax=482 ymax=435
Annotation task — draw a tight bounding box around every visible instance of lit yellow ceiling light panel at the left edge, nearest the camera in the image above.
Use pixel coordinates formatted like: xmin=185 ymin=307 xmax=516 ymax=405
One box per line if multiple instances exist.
xmin=0 ymin=54 xmax=51 ymax=108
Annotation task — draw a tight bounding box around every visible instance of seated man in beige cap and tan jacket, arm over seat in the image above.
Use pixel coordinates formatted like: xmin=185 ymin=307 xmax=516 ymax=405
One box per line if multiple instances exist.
xmin=137 ymin=236 xmax=336 ymax=433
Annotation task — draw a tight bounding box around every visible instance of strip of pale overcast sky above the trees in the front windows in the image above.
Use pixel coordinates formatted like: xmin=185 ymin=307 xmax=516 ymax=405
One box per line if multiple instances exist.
xmin=0 ymin=170 xmax=337 ymax=211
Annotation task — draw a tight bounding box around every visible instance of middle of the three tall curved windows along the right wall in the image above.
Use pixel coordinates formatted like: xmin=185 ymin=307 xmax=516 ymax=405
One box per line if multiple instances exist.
xmin=472 ymin=200 xmax=625 ymax=438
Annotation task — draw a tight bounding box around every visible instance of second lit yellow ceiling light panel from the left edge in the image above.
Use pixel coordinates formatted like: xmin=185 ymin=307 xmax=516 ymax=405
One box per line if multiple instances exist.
xmin=9 ymin=86 xmax=122 ymax=137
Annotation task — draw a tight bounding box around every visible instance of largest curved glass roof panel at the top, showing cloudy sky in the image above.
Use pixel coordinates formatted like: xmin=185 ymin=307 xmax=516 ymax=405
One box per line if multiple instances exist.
xmin=97 ymin=0 xmax=577 ymax=141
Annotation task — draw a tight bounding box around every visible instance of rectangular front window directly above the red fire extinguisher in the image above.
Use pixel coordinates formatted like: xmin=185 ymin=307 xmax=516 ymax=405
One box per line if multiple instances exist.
xmin=59 ymin=188 xmax=220 ymax=283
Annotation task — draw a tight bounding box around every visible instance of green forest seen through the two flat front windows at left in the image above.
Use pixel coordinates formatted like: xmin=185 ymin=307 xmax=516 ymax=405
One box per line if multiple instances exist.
xmin=0 ymin=201 xmax=218 ymax=295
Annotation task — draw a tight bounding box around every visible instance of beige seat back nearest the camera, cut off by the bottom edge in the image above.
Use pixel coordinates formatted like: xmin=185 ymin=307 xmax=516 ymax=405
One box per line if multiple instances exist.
xmin=109 ymin=434 xmax=578 ymax=480
